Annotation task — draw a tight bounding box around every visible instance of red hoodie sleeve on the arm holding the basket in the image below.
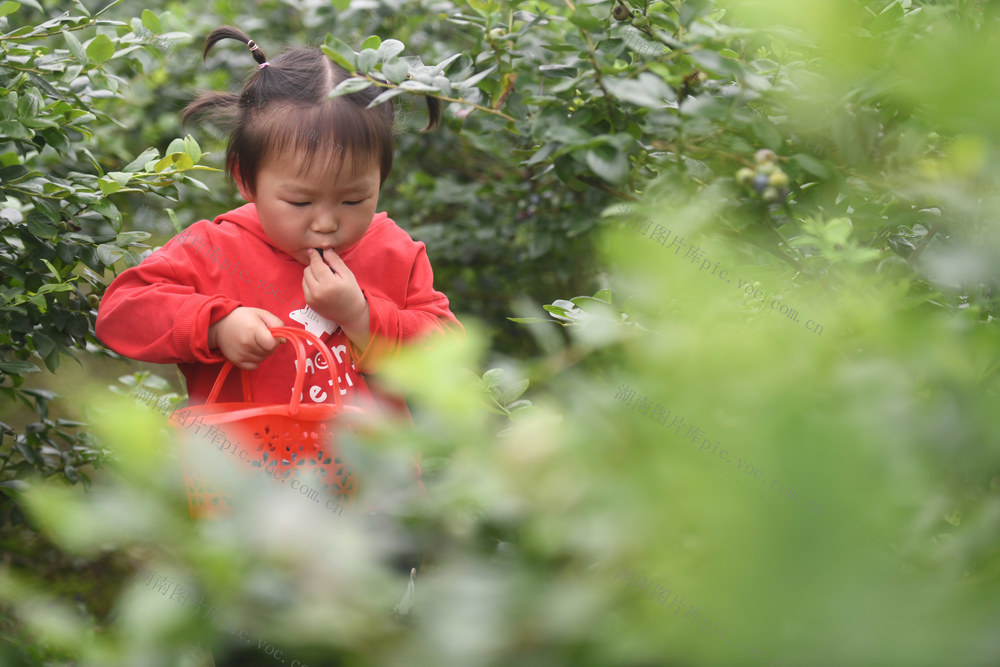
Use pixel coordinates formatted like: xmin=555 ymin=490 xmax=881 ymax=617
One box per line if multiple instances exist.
xmin=95 ymin=229 xmax=242 ymax=364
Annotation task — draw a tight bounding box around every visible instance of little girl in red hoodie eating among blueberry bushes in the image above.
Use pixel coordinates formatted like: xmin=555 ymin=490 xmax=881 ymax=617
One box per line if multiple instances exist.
xmin=96 ymin=27 xmax=461 ymax=412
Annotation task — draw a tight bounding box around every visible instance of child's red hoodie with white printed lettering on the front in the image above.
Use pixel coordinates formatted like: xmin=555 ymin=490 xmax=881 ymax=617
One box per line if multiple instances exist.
xmin=96 ymin=204 xmax=462 ymax=412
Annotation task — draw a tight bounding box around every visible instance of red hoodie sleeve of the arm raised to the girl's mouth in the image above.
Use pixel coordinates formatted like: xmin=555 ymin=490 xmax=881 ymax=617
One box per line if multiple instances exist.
xmin=352 ymin=243 xmax=464 ymax=373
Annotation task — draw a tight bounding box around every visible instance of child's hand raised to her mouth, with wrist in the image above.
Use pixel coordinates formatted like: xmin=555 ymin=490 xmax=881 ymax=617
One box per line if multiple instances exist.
xmin=302 ymin=248 xmax=369 ymax=347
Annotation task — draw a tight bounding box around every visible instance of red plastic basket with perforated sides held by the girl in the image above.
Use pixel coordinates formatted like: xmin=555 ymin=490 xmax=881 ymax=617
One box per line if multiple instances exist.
xmin=172 ymin=327 xmax=361 ymax=518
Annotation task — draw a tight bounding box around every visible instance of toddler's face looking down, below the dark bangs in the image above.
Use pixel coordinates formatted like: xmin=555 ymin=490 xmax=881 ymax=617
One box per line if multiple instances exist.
xmin=236 ymin=151 xmax=381 ymax=265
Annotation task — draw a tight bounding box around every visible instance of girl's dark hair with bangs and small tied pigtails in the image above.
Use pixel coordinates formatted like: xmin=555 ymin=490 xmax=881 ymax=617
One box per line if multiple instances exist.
xmin=181 ymin=26 xmax=441 ymax=194
